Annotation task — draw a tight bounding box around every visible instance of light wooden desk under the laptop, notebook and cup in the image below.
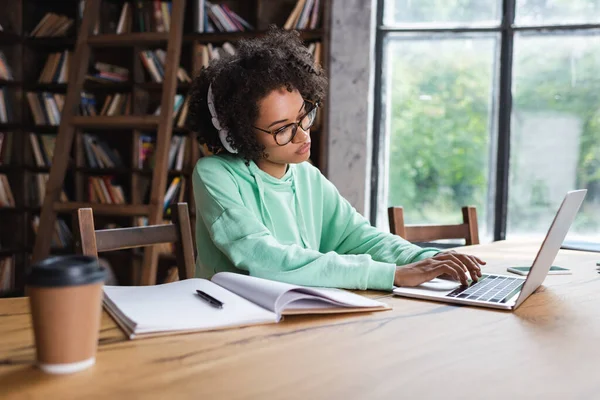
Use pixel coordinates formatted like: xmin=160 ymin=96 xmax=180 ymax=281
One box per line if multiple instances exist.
xmin=0 ymin=242 xmax=600 ymax=400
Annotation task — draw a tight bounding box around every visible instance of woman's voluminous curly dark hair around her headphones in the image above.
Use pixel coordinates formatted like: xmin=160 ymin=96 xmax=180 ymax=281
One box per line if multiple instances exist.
xmin=187 ymin=27 xmax=327 ymax=161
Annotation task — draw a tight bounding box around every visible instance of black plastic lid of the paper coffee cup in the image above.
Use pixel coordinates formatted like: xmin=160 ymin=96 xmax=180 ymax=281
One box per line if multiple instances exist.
xmin=26 ymin=255 xmax=106 ymax=287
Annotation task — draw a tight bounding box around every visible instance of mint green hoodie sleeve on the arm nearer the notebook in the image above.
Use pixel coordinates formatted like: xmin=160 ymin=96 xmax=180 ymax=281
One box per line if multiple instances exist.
xmin=193 ymin=160 xmax=396 ymax=290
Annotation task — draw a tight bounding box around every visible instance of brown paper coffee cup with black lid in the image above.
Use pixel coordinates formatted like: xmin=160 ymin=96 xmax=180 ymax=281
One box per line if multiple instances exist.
xmin=27 ymin=255 xmax=106 ymax=374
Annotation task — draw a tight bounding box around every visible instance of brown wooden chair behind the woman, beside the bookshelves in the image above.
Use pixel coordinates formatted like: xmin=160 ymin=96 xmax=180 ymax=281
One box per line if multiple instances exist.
xmin=77 ymin=203 xmax=195 ymax=284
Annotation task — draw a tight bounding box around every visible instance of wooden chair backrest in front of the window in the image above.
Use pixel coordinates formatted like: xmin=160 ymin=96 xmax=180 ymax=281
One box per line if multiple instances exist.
xmin=388 ymin=207 xmax=479 ymax=245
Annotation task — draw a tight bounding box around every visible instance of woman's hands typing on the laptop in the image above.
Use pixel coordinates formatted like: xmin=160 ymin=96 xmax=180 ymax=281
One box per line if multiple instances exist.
xmin=394 ymin=250 xmax=485 ymax=287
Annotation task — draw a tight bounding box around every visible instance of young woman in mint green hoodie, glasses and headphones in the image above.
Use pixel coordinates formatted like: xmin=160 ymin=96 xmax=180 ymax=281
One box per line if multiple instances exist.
xmin=188 ymin=29 xmax=484 ymax=290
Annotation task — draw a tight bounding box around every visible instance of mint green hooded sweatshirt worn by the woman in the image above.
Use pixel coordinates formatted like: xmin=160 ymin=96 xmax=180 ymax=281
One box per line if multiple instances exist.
xmin=192 ymin=155 xmax=439 ymax=290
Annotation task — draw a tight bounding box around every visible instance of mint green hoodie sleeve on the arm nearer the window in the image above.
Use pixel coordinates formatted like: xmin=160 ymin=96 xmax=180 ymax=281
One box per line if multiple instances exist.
xmin=320 ymin=175 xmax=440 ymax=272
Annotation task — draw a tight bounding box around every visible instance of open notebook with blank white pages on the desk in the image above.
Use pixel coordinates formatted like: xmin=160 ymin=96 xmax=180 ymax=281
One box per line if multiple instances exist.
xmin=104 ymin=272 xmax=390 ymax=339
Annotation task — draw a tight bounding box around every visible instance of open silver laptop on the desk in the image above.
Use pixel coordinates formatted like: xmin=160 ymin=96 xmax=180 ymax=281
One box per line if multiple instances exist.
xmin=393 ymin=189 xmax=587 ymax=310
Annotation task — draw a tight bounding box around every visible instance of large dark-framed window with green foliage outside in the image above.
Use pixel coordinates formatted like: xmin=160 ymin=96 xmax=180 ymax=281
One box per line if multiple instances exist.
xmin=371 ymin=0 xmax=600 ymax=240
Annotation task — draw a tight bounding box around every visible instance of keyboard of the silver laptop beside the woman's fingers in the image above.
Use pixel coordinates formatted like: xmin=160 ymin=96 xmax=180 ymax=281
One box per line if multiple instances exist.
xmin=446 ymin=275 xmax=525 ymax=303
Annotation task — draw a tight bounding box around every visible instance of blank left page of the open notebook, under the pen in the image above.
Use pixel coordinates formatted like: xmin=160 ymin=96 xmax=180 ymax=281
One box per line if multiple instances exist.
xmin=104 ymin=279 xmax=277 ymax=334
